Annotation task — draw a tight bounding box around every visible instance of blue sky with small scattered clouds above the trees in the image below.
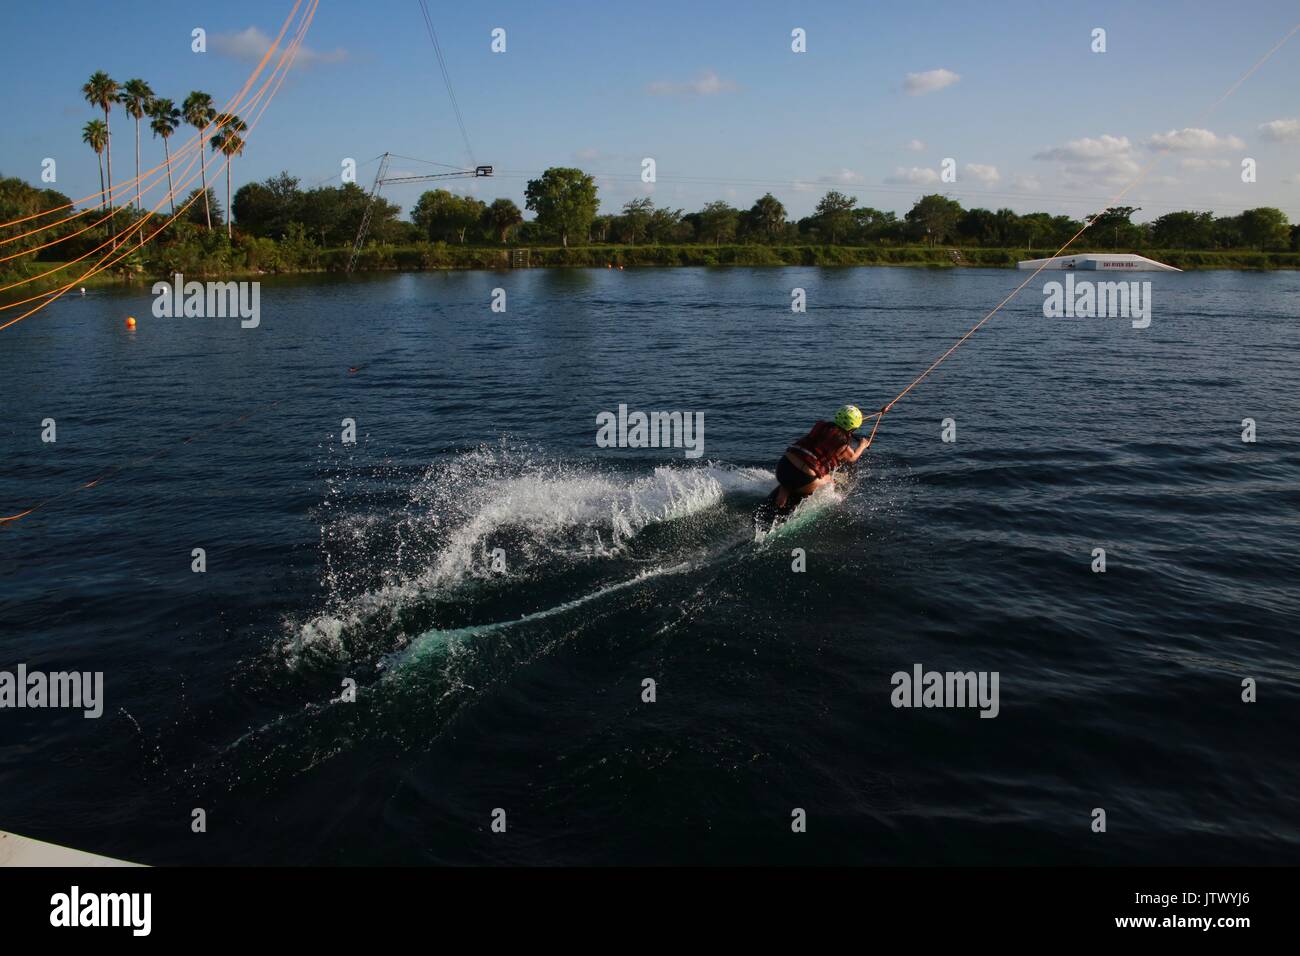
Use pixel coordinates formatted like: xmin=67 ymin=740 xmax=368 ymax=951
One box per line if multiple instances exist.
xmin=0 ymin=0 xmax=1300 ymax=222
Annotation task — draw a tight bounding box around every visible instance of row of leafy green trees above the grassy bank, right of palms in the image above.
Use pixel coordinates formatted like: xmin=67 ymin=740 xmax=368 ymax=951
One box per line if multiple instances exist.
xmin=234 ymin=168 xmax=1297 ymax=251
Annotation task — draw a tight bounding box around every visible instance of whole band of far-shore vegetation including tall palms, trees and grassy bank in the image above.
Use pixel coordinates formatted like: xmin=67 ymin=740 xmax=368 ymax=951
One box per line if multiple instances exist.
xmin=0 ymin=72 xmax=1300 ymax=297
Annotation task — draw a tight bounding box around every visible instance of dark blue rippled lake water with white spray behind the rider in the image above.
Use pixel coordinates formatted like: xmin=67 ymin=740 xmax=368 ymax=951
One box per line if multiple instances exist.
xmin=0 ymin=269 xmax=1300 ymax=864
